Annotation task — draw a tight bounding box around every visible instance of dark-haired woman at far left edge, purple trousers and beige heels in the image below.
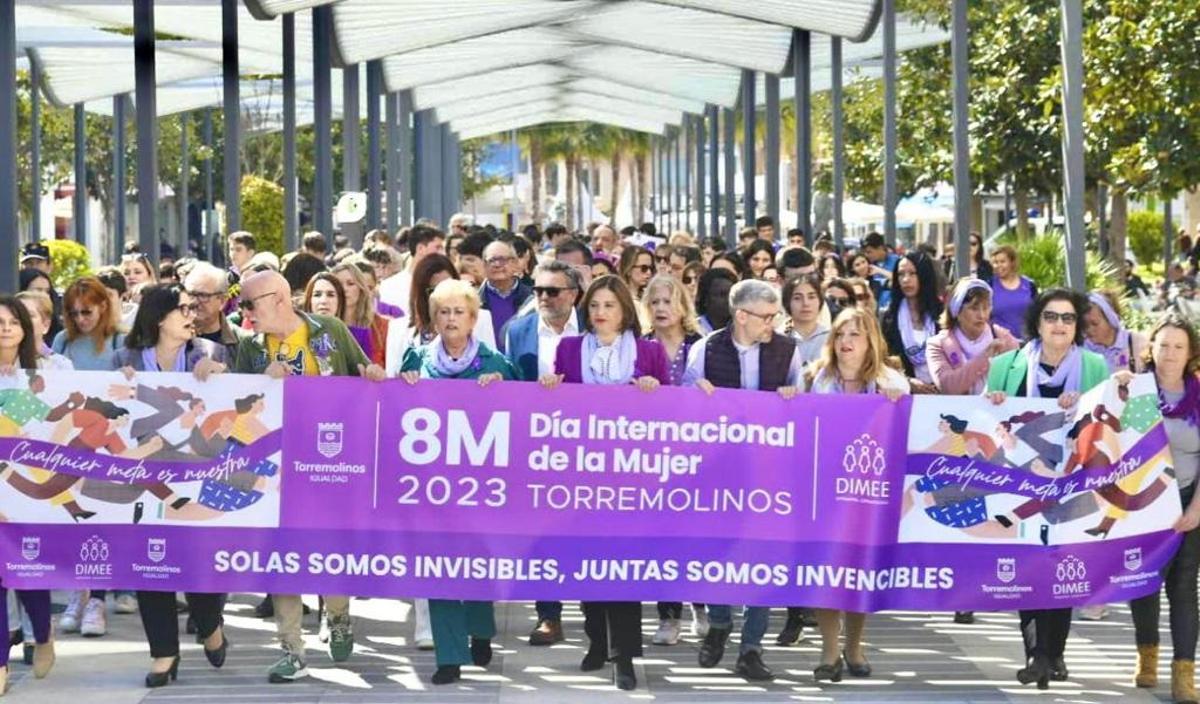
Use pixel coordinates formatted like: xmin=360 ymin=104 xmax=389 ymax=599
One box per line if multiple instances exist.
xmin=0 ymin=296 xmax=54 ymax=697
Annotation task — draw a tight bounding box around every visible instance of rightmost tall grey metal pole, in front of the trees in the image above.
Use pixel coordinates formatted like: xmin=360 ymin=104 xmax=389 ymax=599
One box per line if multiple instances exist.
xmin=1060 ymin=0 xmax=1087 ymax=290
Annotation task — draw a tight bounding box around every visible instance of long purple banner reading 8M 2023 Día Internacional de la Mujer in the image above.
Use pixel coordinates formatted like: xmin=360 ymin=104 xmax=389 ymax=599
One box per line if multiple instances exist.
xmin=0 ymin=373 xmax=1180 ymax=610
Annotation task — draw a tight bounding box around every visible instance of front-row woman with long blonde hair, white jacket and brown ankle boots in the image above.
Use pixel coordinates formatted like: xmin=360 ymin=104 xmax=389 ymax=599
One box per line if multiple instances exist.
xmin=808 ymin=305 xmax=911 ymax=682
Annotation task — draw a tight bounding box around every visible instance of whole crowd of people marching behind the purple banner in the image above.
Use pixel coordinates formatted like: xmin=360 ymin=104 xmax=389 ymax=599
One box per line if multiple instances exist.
xmin=0 ymin=215 xmax=1200 ymax=702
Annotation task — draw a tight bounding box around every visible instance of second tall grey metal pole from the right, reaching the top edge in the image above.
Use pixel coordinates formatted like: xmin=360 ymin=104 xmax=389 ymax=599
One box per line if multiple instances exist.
xmin=950 ymin=0 xmax=971 ymax=277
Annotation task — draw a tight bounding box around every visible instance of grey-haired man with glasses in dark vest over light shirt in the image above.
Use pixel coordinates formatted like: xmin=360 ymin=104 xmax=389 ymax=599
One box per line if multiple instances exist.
xmin=683 ymin=279 xmax=804 ymax=681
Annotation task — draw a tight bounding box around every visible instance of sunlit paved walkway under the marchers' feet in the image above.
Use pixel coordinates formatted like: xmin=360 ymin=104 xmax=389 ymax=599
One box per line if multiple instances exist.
xmin=5 ymin=595 xmax=1170 ymax=704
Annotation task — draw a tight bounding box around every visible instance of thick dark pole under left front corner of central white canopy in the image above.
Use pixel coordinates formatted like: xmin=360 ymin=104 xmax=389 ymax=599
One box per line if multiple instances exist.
xmin=312 ymin=5 xmax=334 ymax=243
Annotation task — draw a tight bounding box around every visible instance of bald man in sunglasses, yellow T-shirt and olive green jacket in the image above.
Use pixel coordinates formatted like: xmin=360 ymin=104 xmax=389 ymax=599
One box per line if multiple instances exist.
xmin=233 ymin=271 xmax=386 ymax=684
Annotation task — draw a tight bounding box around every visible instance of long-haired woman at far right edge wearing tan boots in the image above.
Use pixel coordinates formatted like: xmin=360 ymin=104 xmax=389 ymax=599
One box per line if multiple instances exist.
xmin=1123 ymin=314 xmax=1200 ymax=702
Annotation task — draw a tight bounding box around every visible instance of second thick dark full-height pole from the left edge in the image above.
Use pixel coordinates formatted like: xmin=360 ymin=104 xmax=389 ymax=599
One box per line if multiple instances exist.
xmin=133 ymin=0 xmax=158 ymax=267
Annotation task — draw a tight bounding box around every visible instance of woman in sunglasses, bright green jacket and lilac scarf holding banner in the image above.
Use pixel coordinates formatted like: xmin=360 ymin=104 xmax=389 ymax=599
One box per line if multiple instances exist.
xmin=988 ymin=288 xmax=1109 ymax=690
